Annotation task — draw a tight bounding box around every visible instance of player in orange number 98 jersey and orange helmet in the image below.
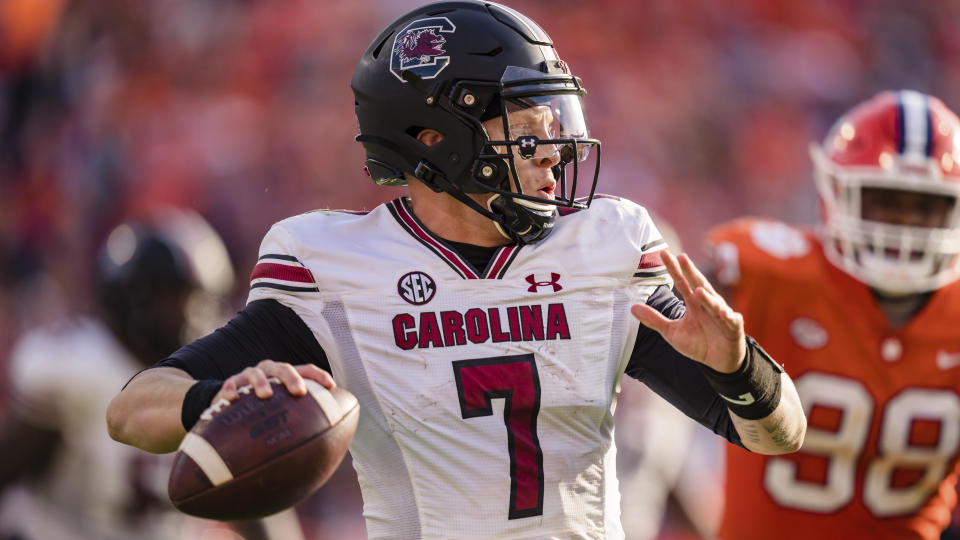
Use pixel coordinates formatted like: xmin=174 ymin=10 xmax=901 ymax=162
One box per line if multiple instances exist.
xmin=709 ymin=91 xmax=960 ymax=540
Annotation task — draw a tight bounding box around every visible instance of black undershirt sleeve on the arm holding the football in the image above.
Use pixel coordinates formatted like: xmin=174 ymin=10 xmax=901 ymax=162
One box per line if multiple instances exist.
xmin=151 ymin=299 xmax=330 ymax=379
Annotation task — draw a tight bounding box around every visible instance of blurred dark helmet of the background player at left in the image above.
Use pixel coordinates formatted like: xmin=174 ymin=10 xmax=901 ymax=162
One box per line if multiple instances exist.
xmin=94 ymin=207 xmax=233 ymax=363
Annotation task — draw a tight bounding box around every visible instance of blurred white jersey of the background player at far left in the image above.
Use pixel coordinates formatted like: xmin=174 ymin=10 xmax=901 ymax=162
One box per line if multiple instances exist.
xmin=0 ymin=318 xmax=181 ymax=540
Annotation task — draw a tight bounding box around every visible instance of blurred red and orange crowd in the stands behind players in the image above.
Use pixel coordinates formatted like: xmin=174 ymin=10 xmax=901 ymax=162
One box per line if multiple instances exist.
xmin=0 ymin=0 xmax=960 ymax=536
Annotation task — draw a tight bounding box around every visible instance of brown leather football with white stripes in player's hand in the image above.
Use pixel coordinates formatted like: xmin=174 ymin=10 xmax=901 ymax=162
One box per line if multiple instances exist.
xmin=167 ymin=378 xmax=360 ymax=521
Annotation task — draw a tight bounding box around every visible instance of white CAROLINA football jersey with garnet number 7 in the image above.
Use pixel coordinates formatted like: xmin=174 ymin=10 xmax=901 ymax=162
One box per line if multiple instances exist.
xmin=248 ymin=197 xmax=670 ymax=539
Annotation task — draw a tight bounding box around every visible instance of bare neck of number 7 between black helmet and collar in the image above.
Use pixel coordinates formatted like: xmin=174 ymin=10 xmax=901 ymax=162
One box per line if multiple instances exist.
xmin=410 ymin=181 xmax=510 ymax=247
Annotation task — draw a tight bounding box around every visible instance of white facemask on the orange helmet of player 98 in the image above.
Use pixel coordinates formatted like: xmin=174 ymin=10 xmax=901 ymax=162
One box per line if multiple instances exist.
xmin=811 ymin=147 xmax=960 ymax=297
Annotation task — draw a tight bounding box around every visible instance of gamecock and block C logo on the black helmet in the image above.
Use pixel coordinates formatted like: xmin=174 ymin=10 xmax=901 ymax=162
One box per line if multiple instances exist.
xmin=390 ymin=17 xmax=457 ymax=82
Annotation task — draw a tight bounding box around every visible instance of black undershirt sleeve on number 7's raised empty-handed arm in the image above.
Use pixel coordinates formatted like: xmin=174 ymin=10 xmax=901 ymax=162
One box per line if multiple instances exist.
xmin=626 ymin=286 xmax=743 ymax=446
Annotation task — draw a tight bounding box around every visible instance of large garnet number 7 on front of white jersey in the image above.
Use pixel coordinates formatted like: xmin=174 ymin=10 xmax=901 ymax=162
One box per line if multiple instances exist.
xmin=453 ymin=354 xmax=543 ymax=519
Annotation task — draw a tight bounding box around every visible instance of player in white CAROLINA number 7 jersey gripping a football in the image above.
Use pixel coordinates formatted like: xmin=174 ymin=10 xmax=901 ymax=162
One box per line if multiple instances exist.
xmin=107 ymin=1 xmax=805 ymax=538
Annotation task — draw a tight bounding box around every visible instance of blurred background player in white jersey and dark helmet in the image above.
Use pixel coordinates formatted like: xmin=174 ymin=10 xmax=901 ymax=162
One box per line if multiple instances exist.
xmin=0 ymin=207 xmax=233 ymax=539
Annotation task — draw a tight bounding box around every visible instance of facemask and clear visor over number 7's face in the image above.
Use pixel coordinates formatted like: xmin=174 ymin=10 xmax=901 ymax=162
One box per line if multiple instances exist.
xmin=464 ymin=67 xmax=600 ymax=243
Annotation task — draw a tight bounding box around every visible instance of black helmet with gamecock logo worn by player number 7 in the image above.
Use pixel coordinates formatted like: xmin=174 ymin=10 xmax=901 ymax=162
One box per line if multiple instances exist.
xmin=352 ymin=1 xmax=600 ymax=243
